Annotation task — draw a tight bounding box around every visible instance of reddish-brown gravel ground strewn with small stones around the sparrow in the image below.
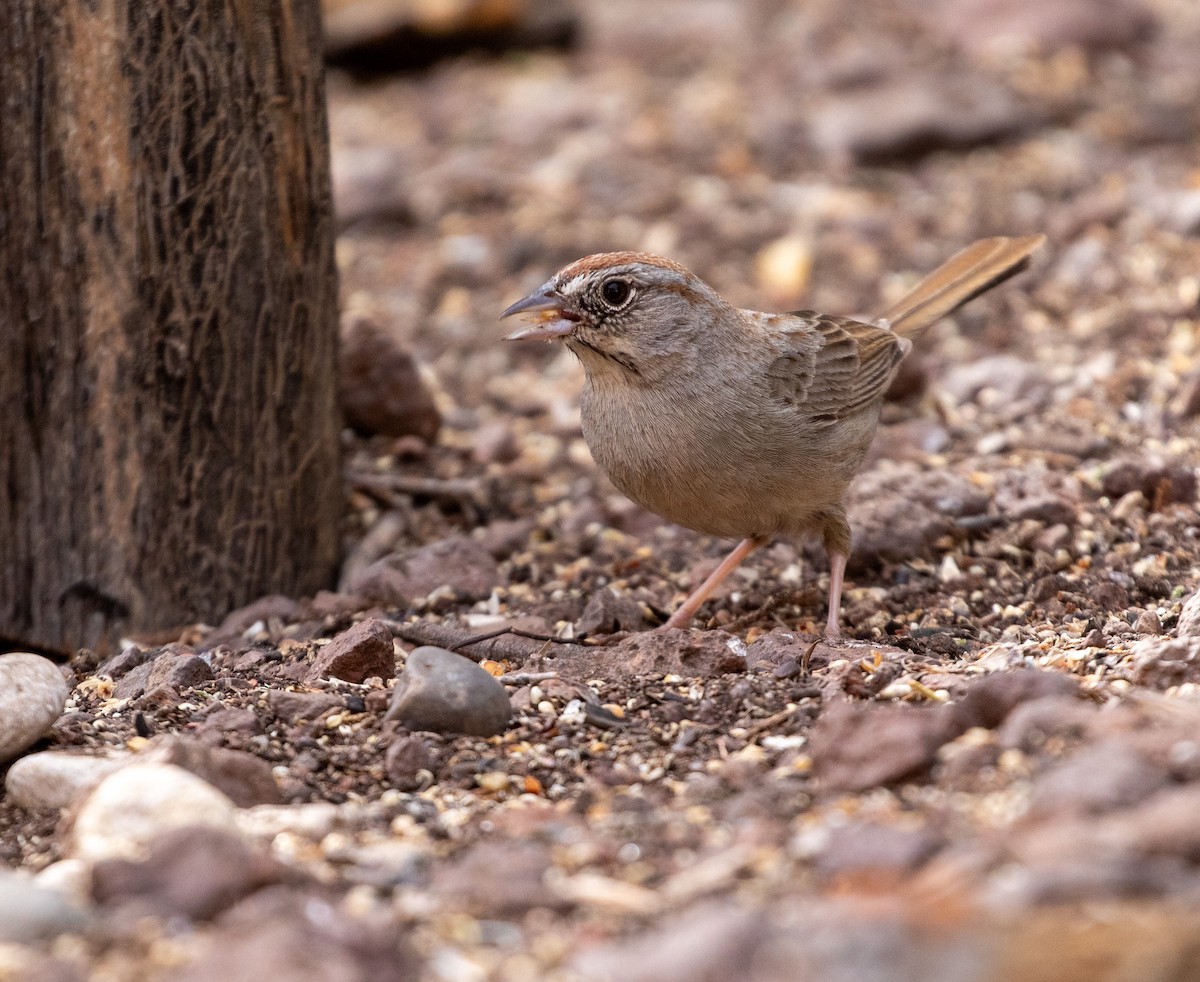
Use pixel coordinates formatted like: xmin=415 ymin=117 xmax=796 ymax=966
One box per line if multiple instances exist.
xmin=0 ymin=0 xmax=1200 ymax=982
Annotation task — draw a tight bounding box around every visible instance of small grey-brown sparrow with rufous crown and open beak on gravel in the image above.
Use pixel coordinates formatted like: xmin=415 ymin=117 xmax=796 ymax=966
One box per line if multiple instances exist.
xmin=502 ymin=235 xmax=1045 ymax=637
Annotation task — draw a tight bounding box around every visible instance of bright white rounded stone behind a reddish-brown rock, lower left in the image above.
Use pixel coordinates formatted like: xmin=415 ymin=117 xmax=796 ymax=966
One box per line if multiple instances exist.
xmin=70 ymin=761 xmax=238 ymax=862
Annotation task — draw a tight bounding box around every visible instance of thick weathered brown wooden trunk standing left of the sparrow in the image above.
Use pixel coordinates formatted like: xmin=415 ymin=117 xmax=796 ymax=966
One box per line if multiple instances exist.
xmin=0 ymin=0 xmax=341 ymax=651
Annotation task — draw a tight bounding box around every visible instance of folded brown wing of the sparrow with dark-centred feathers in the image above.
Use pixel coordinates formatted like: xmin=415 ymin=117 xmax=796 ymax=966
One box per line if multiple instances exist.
xmin=767 ymin=310 xmax=912 ymax=423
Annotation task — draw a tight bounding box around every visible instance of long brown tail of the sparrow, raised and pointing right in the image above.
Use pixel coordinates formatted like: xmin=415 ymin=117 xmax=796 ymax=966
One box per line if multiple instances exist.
xmin=878 ymin=235 xmax=1046 ymax=335
